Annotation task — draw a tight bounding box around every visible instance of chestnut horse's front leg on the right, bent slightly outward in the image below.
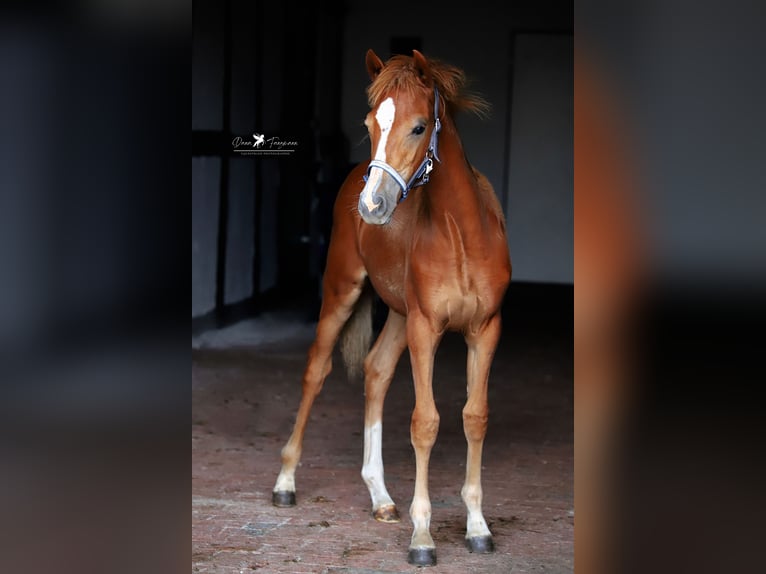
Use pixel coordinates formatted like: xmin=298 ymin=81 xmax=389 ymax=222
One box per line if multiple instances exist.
xmin=460 ymin=314 xmax=500 ymax=553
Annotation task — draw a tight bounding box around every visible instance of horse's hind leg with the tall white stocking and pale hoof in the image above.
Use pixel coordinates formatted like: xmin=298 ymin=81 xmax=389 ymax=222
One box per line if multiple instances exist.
xmin=362 ymin=310 xmax=407 ymax=522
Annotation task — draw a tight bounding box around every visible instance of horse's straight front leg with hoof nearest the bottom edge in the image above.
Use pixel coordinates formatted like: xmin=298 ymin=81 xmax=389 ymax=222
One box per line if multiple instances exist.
xmin=407 ymin=312 xmax=442 ymax=566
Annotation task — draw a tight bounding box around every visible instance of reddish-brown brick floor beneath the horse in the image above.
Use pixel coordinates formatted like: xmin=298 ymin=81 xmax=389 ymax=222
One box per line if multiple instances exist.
xmin=192 ymin=294 xmax=574 ymax=574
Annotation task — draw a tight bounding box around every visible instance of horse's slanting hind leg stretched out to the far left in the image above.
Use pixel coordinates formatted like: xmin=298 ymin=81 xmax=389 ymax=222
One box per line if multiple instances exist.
xmin=272 ymin=281 xmax=363 ymax=507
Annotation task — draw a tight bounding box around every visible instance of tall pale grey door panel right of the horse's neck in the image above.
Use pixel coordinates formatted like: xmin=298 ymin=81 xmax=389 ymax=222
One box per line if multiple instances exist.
xmin=506 ymin=34 xmax=574 ymax=283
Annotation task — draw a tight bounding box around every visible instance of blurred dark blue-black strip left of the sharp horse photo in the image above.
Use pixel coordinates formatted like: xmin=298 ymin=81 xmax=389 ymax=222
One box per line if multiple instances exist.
xmin=0 ymin=4 xmax=191 ymax=573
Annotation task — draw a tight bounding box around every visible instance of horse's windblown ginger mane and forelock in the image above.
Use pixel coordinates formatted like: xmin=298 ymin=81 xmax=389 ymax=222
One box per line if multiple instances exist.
xmin=367 ymin=55 xmax=490 ymax=118
